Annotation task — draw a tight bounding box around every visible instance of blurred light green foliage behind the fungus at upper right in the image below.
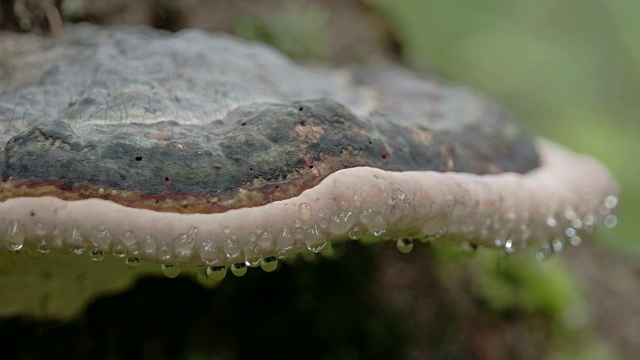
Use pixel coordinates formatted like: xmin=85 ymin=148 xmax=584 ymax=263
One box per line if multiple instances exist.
xmin=368 ymin=0 xmax=640 ymax=259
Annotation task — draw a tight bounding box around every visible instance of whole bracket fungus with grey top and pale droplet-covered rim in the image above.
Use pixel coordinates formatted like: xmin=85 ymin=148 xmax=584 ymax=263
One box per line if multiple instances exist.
xmin=0 ymin=26 xmax=617 ymax=316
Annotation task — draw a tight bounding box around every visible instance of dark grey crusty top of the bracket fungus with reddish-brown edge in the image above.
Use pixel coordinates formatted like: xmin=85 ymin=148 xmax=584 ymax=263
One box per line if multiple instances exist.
xmin=0 ymin=26 xmax=539 ymax=213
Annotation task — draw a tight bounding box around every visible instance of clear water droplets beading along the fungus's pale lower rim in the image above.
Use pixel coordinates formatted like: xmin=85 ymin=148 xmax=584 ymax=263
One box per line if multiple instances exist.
xmin=0 ymin=188 xmax=618 ymax=281
